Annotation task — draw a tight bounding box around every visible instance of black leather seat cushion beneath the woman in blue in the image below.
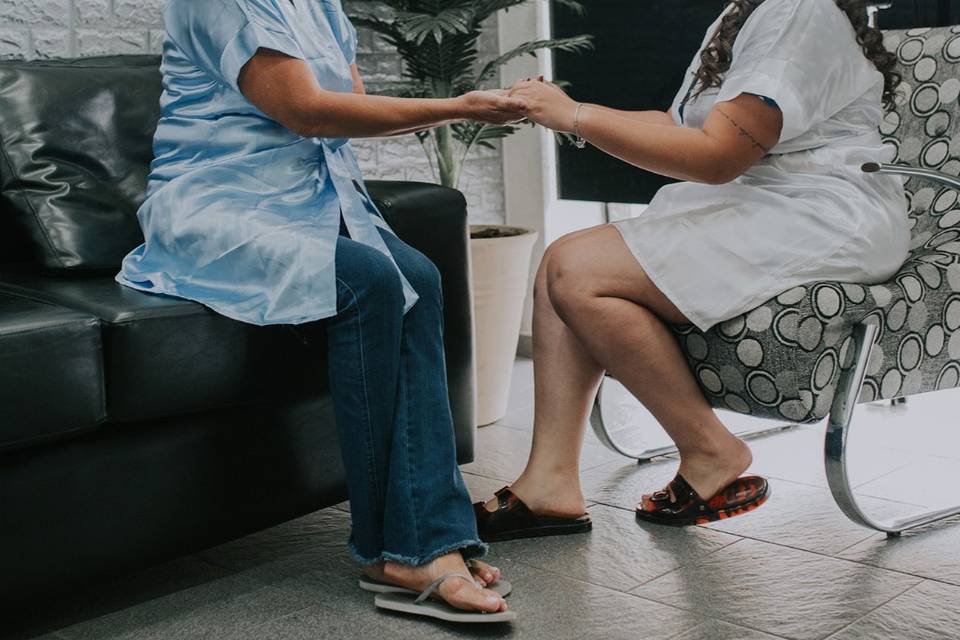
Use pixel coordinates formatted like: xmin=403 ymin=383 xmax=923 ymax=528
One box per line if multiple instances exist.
xmin=0 ymin=275 xmax=327 ymax=422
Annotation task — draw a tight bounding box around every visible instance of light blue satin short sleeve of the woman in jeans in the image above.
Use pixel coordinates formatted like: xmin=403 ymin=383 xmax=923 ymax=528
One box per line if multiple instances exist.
xmin=168 ymin=0 xmax=304 ymax=92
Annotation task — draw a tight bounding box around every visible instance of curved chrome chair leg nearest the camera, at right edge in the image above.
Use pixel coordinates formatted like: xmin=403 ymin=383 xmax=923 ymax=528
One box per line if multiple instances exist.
xmin=824 ymin=324 xmax=960 ymax=536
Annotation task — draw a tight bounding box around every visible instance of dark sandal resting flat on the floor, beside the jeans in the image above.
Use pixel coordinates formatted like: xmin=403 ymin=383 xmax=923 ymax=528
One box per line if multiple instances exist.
xmin=473 ymin=487 xmax=593 ymax=542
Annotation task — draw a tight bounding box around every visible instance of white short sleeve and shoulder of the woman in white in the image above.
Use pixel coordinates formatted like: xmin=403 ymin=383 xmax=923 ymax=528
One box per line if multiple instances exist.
xmin=717 ymin=0 xmax=876 ymax=142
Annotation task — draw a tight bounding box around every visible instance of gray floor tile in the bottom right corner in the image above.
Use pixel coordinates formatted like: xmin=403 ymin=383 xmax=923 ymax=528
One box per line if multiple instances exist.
xmin=830 ymin=581 xmax=960 ymax=640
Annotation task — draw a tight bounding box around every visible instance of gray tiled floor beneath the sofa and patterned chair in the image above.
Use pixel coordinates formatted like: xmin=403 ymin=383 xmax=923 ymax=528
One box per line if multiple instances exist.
xmin=7 ymin=360 xmax=960 ymax=640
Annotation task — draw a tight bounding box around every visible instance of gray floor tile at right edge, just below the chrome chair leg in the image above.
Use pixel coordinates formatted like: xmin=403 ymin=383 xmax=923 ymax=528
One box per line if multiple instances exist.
xmin=840 ymin=517 xmax=960 ymax=585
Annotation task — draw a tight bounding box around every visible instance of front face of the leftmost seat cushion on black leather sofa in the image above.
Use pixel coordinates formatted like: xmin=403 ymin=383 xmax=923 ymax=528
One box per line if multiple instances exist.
xmin=0 ymin=287 xmax=104 ymax=450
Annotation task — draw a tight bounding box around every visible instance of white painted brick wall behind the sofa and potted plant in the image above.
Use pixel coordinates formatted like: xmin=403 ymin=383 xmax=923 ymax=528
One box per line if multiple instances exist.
xmin=0 ymin=0 xmax=504 ymax=223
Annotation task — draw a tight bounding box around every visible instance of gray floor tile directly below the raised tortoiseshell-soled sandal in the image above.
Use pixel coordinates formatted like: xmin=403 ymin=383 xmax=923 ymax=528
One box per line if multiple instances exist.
xmin=484 ymin=505 xmax=739 ymax=591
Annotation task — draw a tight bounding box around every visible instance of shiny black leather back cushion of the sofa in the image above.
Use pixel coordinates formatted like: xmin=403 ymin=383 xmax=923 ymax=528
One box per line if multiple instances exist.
xmin=0 ymin=56 xmax=160 ymax=270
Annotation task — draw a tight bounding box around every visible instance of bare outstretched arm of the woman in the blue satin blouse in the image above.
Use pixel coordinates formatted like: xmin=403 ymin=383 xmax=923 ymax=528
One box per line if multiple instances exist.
xmin=238 ymin=49 xmax=524 ymax=138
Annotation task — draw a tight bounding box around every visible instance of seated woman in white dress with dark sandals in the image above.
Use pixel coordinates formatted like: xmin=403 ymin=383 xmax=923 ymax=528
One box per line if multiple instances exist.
xmin=475 ymin=0 xmax=909 ymax=541
